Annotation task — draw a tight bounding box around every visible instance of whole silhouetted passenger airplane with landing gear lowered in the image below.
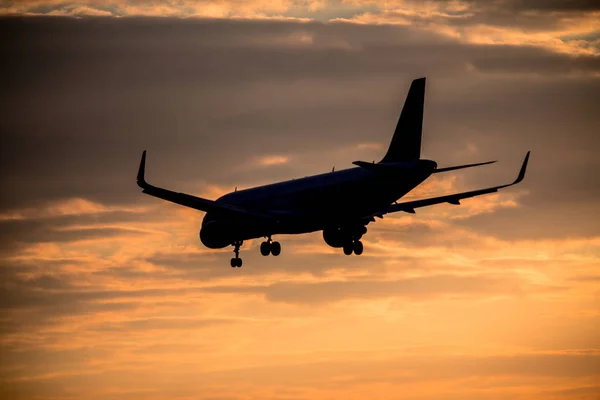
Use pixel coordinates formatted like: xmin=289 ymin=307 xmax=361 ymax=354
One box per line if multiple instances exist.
xmin=137 ymin=78 xmax=530 ymax=268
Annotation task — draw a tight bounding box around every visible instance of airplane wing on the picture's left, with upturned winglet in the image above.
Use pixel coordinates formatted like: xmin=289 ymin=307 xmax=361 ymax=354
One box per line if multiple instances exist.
xmin=137 ymin=150 xmax=277 ymax=222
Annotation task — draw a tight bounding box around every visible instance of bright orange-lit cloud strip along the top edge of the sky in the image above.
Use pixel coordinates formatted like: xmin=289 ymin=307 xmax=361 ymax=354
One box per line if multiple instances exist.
xmin=0 ymin=0 xmax=600 ymax=55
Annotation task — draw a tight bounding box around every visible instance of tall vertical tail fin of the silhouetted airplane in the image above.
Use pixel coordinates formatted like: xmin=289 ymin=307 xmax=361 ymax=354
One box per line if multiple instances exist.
xmin=380 ymin=78 xmax=425 ymax=163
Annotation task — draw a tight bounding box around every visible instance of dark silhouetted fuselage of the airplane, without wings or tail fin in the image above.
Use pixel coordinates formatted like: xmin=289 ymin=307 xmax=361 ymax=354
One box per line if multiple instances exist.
xmin=200 ymin=160 xmax=437 ymax=248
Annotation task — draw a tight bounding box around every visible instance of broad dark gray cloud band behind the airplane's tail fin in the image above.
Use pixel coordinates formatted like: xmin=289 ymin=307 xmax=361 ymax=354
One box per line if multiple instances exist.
xmin=0 ymin=18 xmax=600 ymax=238
